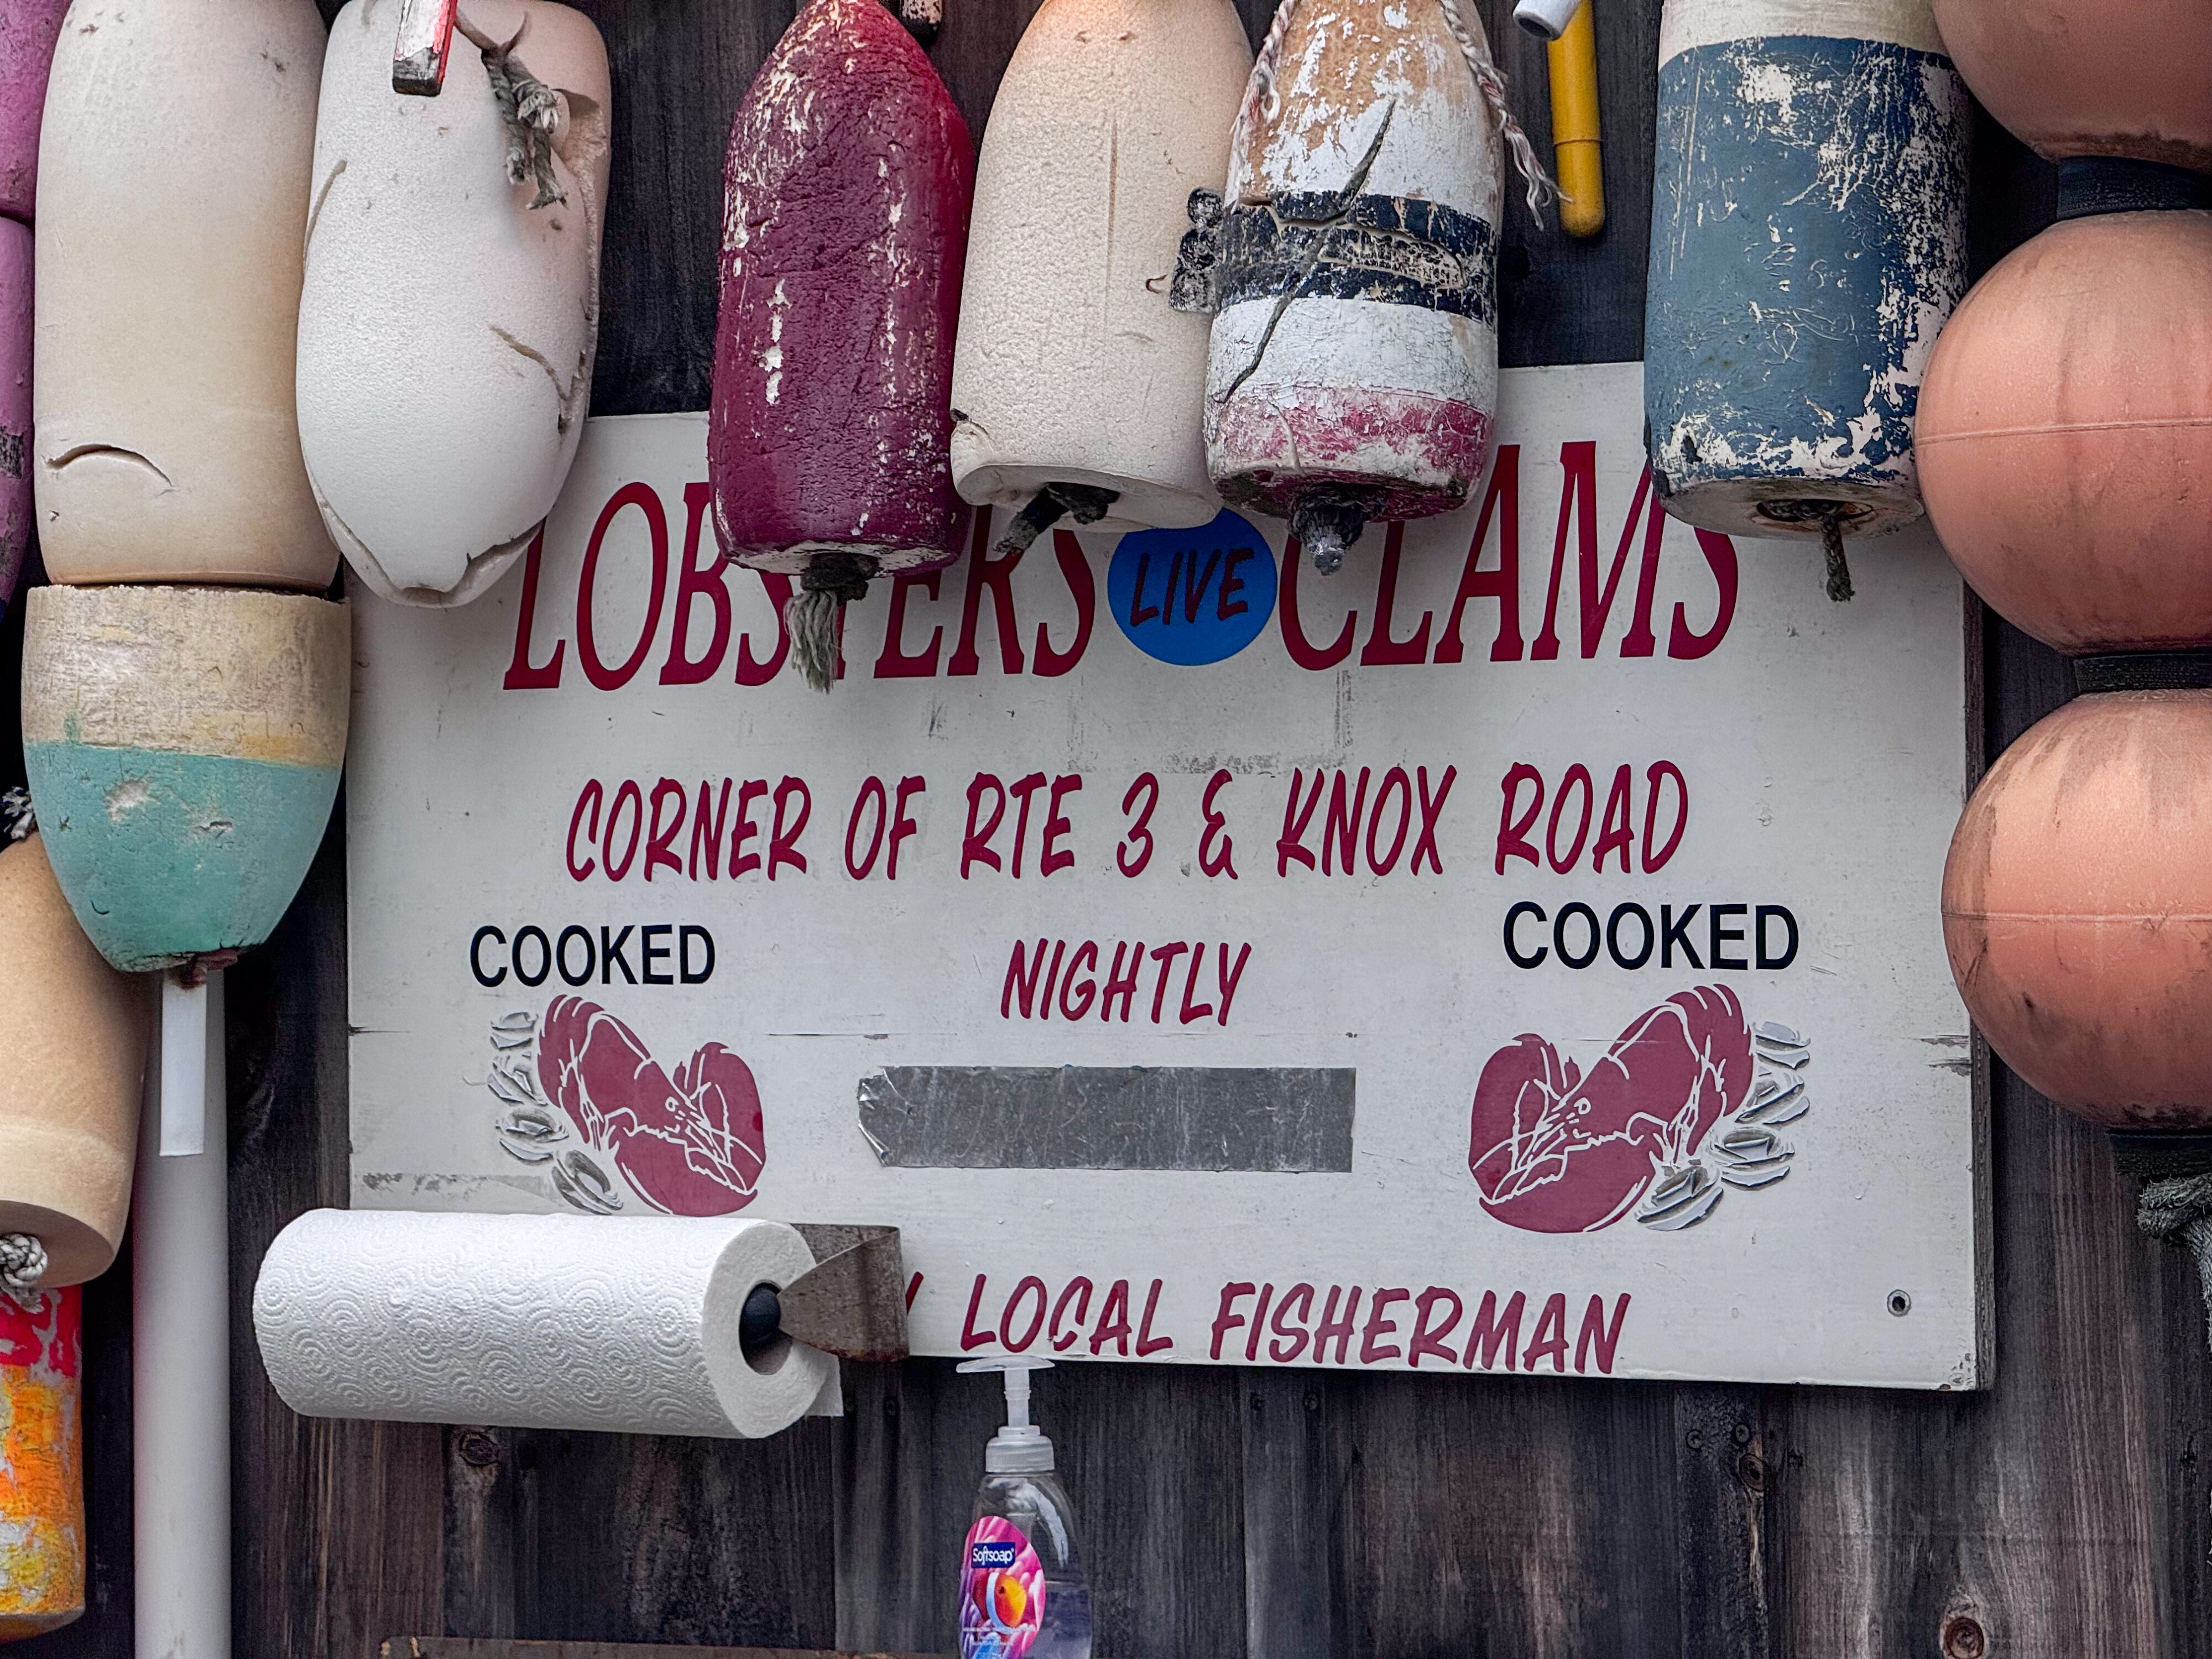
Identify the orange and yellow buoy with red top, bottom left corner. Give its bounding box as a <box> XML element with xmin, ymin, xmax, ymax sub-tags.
<box><xmin>0</xmin><ymin>1290</ymin><xmax>84</xmax><ymax>1641</ymax></box>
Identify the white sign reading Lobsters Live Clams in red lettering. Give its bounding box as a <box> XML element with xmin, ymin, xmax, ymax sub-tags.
<box><xmin>349</xmin><ymin>365</ymin><xmax>1986</xmax><ymax>1387</ymax></box>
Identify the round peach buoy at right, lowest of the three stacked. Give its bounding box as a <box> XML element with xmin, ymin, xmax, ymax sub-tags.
<box><xmin>1942</xmin><ymin>690</ymin><xmax>2212</xmax><ymax>1130</ymax></box>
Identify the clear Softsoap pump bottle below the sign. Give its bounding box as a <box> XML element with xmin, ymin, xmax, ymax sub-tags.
<box><xmin>960</xmin><ymin>1358</ymin><xmax>1091</xmax><ymax>1659</ymax></box>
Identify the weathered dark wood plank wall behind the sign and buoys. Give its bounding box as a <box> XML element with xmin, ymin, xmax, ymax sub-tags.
<box><xmin>0</xmin><ymin>0</ymin><xmax>2212</xmax><ymax>1659</ymax></box>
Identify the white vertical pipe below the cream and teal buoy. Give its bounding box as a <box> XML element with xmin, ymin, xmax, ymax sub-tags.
<box><xmin>131</xmin><ymin>973</ymin><xmax>230</xmax><ymax>1659</ymax></box>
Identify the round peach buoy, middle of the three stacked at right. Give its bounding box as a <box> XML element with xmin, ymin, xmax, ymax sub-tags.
<box><xmin>1918</xmin><ymin>210</ymin><xmax>2212</xmax><ymax>653</ymax></box>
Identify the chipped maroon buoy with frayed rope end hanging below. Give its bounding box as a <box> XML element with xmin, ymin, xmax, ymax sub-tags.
<box><xmin>708</xmin><ymin>0</ymin><xmax>975</xmax><ymax>690</ymax></box>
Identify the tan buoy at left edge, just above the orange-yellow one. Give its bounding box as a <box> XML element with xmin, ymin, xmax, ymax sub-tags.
<box><xmin>0</xmin><ymin>834</ymin><xmax>150</xmax><ymax>1312</ymax></box>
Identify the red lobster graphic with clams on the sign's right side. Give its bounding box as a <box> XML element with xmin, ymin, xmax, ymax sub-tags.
<box><xmin>1467</xmin><ymin>984</ymin><xmax>1761</xmax><ymax>1232</ymax></box>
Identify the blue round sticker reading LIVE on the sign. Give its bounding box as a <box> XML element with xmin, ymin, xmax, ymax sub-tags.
<box><xmin>1106</xmin><ymin>511</ymin><xmax>1274</xmax><ymax>668</ymax></box>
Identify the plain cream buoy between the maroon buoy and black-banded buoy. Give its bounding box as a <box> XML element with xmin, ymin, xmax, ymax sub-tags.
<box><xmin>951</xmin><ymin>0</ymin><xmax>1252</xmax><ymax>560</ymax></box>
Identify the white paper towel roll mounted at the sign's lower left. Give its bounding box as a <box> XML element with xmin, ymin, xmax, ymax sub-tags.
<box><xmin>254</xmin><ymin>1210</ymin><xmax>836</xmax><ymax>1440</ymax></box>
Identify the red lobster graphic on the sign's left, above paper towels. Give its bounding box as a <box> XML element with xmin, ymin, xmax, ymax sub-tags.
<box><xmin>538</xmin><ymin>998</ymin><xmax>768</xmax><ymax>1214</ymax></box>
